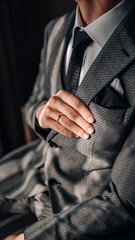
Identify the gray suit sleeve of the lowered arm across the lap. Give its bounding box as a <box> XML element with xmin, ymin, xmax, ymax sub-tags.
<box><xmin>25</xmin><ymin>121</ymin><xmax>135</xmax><ymax>240</ymax></box>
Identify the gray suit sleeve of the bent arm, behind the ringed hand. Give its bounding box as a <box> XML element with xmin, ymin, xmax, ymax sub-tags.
<box><xmin>25</xmin><ymin>23</ymin><xmax>51</xmax><ymax>138</ymax></box>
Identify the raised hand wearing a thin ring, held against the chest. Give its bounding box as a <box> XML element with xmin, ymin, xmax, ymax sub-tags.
<box><xmin>36</xmin><ymin>90</ymin><xmax>94</xmax><ymax>139</ymax></box>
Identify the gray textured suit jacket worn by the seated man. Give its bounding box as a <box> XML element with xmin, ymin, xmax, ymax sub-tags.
<box><xmin>8</xmin><ymin>5</ymin><xmax>135</xmax><ymax>240</ymax></box>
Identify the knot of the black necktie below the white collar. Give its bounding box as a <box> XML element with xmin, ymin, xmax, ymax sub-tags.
<box><xmin>73</xmin><ymin>27</ymin><xmax>93</xmax><ymax>51</ymax></box>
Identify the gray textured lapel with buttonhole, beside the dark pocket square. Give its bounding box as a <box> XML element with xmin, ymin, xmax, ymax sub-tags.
<box><xmin>76</xmin><ymin>4</ymin><xmax>135</xmax><ymax>105</ymax></box>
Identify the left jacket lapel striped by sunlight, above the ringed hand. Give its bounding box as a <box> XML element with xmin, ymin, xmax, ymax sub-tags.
<box><xmin>48</xmin><ymin>10</ymin><xmax>75</xmax><ymax>95</ymax></box>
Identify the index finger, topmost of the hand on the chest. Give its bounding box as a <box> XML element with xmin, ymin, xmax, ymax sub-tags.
<box><xmin>56</xmin><ymin>90</ymin><xmax>94</xmax><ymax>123</ymax></box>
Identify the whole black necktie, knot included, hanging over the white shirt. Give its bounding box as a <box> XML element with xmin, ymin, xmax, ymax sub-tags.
<box><xmin>65</xmin><ymin>27</ymin><xmax>93</xmax><ymax>94</ymax></box>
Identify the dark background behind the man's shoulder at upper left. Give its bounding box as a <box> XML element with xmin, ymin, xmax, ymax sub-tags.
<box><xmin>0</xmin><ymin>0</ymin><xmax>75</xmax><ymax>156</ymax></box>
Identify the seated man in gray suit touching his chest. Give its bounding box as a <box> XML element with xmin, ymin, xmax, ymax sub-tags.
<box><xmin>0</xmin><ymin>0</ymin><xmax>135</xmax><ymax>240</ymax></box>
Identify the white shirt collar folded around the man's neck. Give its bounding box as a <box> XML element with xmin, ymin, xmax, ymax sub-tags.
<box><xmin>74</xmin><ymin>0</ymin><xmax>133</xmax><ymax>48</ymax></box>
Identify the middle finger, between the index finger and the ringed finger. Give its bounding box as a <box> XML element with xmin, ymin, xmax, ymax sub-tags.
<box><xmin>46</xmin><ymin>97</ymin><xmax>94</xmax><ymax>136</ymax></box>
